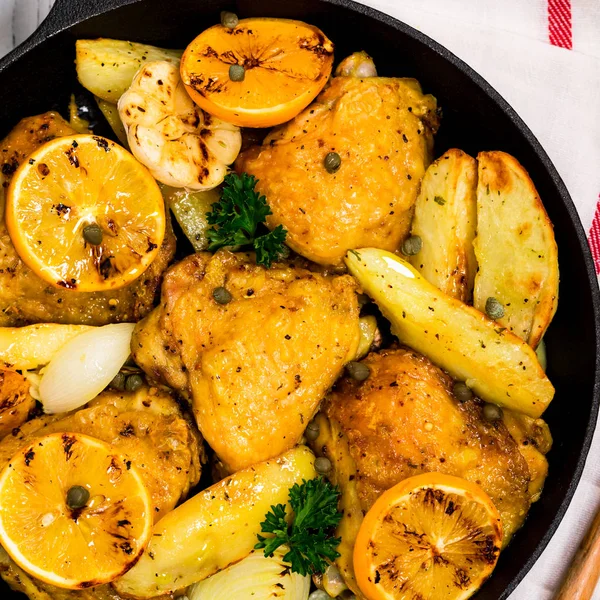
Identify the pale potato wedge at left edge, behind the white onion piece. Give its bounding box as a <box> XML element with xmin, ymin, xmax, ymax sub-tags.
<box><xmin>0</xmin><ymin>323</ymin><xmax>92</xmax><ymax>371</ymax></box>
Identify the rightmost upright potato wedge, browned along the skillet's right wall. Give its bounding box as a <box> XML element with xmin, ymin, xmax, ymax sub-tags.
<box><xmin>473</xmin><ymin>152</ymin><xmax>558</xmax><ymax>348</ymax></box>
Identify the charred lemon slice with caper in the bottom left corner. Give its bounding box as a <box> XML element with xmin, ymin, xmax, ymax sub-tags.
<box><xmin>0</xmin><ymin>433</ymin><xmax>152</xmax><ymax>589</ymax></box>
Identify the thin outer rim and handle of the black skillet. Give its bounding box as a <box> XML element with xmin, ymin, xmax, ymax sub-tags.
<box><xmin>0</xmin><ymin>0</ymin><xmax>600</xmax><ymax>598</ymax></box>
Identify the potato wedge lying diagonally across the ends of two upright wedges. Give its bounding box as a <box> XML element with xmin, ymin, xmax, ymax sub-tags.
<box><xmin>346</xmin><ymin>248</ymin><xmax>554</xmax><ymax>417</ymax></box>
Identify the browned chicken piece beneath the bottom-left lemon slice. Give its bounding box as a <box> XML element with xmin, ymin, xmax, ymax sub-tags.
<box><xmin>0</xmin><ymin>386</ymin><xmax>205</xmax><ymax>600</ymax></box>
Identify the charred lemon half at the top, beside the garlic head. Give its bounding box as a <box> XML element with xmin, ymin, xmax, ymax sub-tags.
<box><xmin>181</xmin><ymin>19</ymin><xmax>333</xmax><ymax>127</ymax></box>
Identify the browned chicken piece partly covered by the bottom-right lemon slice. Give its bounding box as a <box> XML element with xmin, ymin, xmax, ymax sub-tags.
<box><xmin>314</xmin><ymin>348</ymin><xmax>545</xmax><ymax>598</ymax></box>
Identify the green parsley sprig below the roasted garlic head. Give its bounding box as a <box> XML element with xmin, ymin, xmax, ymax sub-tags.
<box><xmin>206</xmin><ymin>173</ymin><xmax>287</xmax><ymax>269</ymax></box>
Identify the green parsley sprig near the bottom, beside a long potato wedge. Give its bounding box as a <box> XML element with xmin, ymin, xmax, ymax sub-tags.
<box><xmin>255</xmin><ymin>478</ymin><xmax>342</xmax><ymax>575</ymax></box>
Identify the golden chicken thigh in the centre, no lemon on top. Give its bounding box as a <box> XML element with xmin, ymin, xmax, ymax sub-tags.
<box><xmin>131</xmin><ymin>251</ymin><xmax>359</xmax><ymax>471</ymax></box>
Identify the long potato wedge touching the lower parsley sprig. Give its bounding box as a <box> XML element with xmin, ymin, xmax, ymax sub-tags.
<box><xmin>113</xmin><ymin>446</ymin><xmax>316</xmax><ymax>598</ymax></box>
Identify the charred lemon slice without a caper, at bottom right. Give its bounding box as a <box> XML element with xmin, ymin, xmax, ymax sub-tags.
<box><xmin>354</xmin><ymin>473</ymin><xmax>502</xmax><ymax>600</ymax></box>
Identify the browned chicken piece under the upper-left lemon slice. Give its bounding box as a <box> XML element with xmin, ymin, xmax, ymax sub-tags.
<box><xmin>0</xmin><ymin>112</ymin><xmax>175</xmax><ymax>327</ymax></box>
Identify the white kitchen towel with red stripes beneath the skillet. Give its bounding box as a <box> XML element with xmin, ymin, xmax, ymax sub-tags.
<box><xmin>0</xmin><ymin>0</ymin><xmax>600</xmax><ymax>600</ymax></box>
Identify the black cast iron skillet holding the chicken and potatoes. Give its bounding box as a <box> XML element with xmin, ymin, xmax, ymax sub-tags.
<box><xmin>0</xmin><ymin>0</ymin><xmax>600</xmax><ymax>600</ymax></box>
